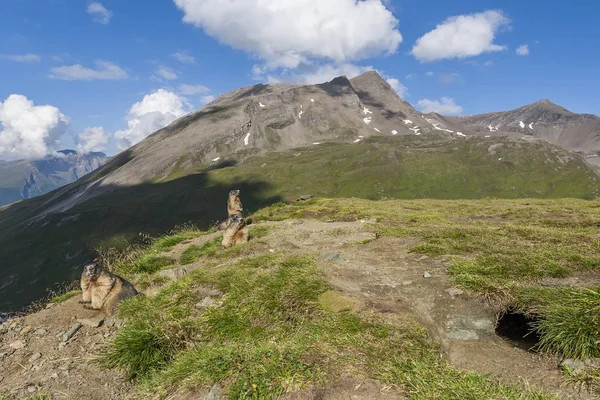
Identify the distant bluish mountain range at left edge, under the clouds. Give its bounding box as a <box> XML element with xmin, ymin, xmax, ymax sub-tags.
<box><xmin>0</xmin><ymin>150</ymin><xmax>108</xmax><ymax>206</ymax></box>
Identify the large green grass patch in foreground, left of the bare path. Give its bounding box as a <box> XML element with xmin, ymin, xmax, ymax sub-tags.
<box><xmin>102</xmin><ymin>254</ymin><xmax>549</xmax><ymax>400</ymax></box>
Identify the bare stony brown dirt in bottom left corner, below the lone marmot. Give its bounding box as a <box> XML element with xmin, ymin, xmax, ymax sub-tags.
<box><xmin>0</xmin><ymin>296</ymin><xmax>132</xmax><ymax>400</ymax></box>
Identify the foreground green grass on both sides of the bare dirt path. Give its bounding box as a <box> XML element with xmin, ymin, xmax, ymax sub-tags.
<box><xmin>92</xmin><ymin>199</ymin><xmax>600</xmax><ymax>400</ymax></box>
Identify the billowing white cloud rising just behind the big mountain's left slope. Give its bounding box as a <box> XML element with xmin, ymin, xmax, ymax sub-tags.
<box><xmin>115</xmin><ymin>89</ymin><xmax>190</xmax><ymax>150</ymax></box>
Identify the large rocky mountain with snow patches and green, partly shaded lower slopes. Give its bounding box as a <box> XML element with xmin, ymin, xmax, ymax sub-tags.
<box><xmin>0</xmin><ymin>72</ymin><xmax>600</xmax><ymax>312</ymax></box>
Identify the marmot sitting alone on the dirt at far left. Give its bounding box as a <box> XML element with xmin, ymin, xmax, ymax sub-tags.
<box><xmin>81</xmin><ymin>263</ymin><xmax>138</xmax><ymax>317</ymax></box>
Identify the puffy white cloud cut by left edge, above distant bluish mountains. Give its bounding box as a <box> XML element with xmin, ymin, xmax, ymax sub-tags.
<box><xmin>0</xmin><ymin>94</ymin><xmax>69</xmax><ymax>160</ymax></box>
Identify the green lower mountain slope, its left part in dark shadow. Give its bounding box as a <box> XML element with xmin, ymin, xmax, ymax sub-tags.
<box><xmin>0</xmin><ymin>136</ymin><xmax>600</xmax><ymax>311</ymax></box>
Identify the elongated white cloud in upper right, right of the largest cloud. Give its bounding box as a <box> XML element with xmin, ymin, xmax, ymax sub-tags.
<box><xmin>411</xmin><ymin>10</ymin><xmax>510</xmax><ymax>62</ymax></box>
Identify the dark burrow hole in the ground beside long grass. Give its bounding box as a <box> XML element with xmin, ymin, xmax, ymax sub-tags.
<box><xmin>496</xmin><ymin>309</ymin><xmax>540</xmax><ymax>351</ymax></box>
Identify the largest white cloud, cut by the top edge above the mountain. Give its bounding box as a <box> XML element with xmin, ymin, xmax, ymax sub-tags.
<box><xmin>174</xmin><ymin>0</ymin><xmax>402</xmax><ymax>68</ymax></box>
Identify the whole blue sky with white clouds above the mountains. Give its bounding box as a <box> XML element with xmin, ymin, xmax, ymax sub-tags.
<box><xmin>0</xmin><ymin>0</ymin><xmax>600</xmax><ymax>159</ymax></box>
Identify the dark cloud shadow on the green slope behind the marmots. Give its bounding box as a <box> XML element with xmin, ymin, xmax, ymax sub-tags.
<box><xmin>0</xmin><ymin>172</ymin><xmax>282</xmax><ymax>312</ymax></box>
